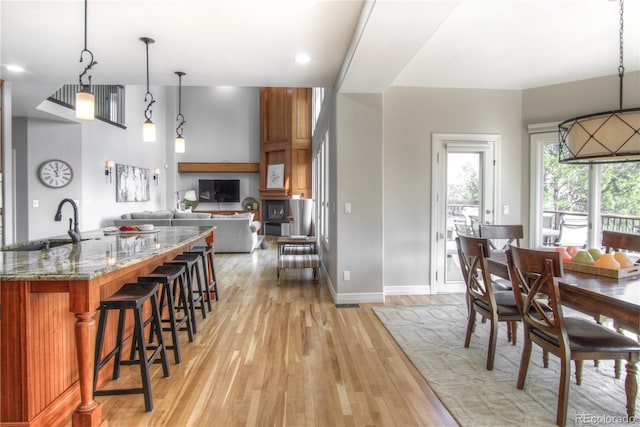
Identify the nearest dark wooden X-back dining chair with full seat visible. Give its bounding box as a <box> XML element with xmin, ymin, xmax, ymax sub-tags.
<box><xmin>508</xmin><ymin>246</ymin><xmax>640</xmax><ymax>426</ymax></box>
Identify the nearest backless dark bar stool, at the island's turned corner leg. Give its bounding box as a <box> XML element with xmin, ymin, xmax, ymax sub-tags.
<box><xmin>93</xmin><ymin>283</ymin><xmax>169</xmax><ymax>412</ymax></box>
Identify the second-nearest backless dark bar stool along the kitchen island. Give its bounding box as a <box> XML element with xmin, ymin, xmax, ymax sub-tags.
<box><xmin>138</xmin><ymin>264</ymin><xmax>193</xmax><ymax>365</ymax></box>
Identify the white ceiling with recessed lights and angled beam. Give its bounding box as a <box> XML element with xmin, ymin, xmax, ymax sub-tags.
<box><xmin>0</xmin><ymin>0</ymin><xmax>640</xmax><ymax>115</ymax></box>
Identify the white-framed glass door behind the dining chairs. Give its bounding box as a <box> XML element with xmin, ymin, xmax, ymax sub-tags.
<box><xmin>431</xmin><ymin>134</ymin><xmax>500</xmax><ymax>293</ymax></box>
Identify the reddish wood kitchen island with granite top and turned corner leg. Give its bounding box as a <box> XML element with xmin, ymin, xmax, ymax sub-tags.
<box><xmin>0</xmin><ymin>227</ymin><xmax>215</xmax><ymax>426</ymax></box>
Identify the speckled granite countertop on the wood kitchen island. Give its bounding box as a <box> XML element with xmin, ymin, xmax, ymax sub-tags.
<box><xmin>0</xmin><ymin>226</ymin><xmax>215</xmax><ymax>281</ymax></box>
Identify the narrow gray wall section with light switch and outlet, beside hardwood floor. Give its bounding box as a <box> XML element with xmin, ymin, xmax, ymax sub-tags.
<box><xmin>335</xmin><ymin>94</ymin><xmax>384</xmax><ymax>303</ymax></box>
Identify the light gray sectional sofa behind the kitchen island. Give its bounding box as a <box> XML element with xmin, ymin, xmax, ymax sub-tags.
<box><xmin>113</xmin><ymin>210</ymin><xmax>262</xmax><ymax>253</ymax></box>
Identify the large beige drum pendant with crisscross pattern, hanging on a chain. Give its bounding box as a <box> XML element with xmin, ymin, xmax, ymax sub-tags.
<box><xmin>558</xmin><ymin>0</ymin><xmax>640</xmax><ymax>163</ymax></box>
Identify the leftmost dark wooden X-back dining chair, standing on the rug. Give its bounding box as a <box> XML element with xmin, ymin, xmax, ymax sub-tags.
<box><xmin>456</xmin><ymin>236</ymin><xmax>520</xmax><ymax>370</ymax></box>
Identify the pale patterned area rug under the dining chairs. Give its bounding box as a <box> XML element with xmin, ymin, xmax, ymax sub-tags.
<box><xmin>373</xmin><ymin>305</ymin><xmax>628</xmax><ymax>426</ymax></box>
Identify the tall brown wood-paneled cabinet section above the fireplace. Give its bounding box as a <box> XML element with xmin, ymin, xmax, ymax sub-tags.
<box><xmin>260</xmin><ymin>87</ymin><xmax>311</xmax><ymax>200</ymax></box>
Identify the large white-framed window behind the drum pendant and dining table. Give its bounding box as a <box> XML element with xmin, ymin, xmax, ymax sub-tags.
<box><xmin>531</xmin><ymin>131</ymin><xmax>640</xmax><ymax>247</ymax></box>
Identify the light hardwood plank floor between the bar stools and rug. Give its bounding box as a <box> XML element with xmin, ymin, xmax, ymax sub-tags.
<box><xmin>87</xmin><ymin>238</ymin><xmax>462</xmax><ymax>427</ymax></box>
